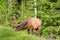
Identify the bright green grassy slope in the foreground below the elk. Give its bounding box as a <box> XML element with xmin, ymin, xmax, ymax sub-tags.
<box><xmin>0</xmin><ymin>27</ymin><xmax>60</xmax><ymax>40</ymax></box>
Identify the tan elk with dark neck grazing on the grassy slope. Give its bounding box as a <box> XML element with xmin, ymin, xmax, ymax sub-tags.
<box><xmin>9</xmin><ymin>18</ymin><xmax>42</xmax><ymax>36</ymax></box>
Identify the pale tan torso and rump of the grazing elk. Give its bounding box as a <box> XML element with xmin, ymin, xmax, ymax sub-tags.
<box><xmin>26</xmin><ymin>18</ymin><xmax>42</xmax><ymax>29</ymax></box>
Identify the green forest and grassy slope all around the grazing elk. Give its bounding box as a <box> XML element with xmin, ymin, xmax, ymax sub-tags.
<box><xmin>0</xmin><ymin>0</ymin><xmax>60</xmax><ymax>40</ymax></box>
